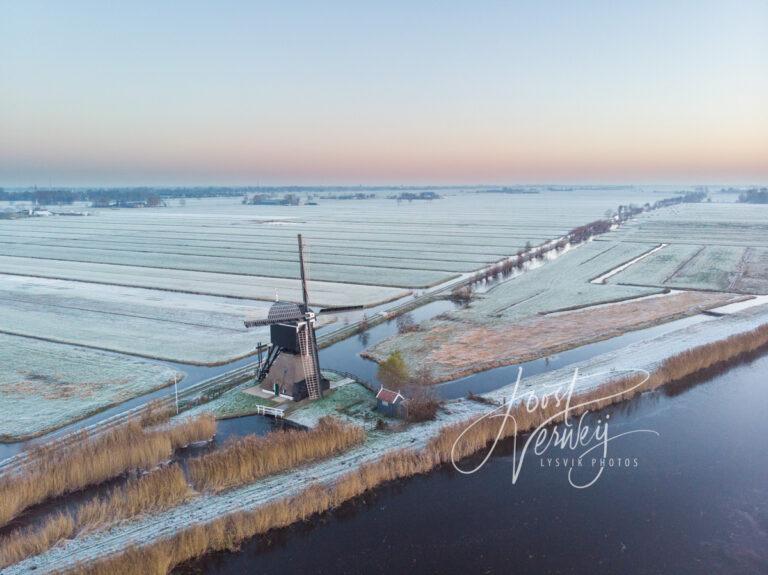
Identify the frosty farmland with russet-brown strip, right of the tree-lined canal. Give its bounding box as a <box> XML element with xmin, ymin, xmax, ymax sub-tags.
<box><xmin>368</xmin><ymin>203</ymin><xmax>768</xmax><ymax>380</ymax></box>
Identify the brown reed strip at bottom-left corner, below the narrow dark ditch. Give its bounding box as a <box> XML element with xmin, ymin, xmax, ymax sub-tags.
<box><xmin>0</xmin><ymin>465</ymin><xmax>190</xmax><ymax>569</ymax></box>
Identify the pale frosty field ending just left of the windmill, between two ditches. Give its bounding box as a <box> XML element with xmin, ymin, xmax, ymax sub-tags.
<box><xmin>0</xmin><ymin>276</ymin><xmax>269</xmax><ymax>364</ymax></box>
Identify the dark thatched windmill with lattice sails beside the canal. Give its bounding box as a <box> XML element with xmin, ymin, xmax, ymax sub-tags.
<box><xmin>245</xmin><ymin>234</ymin><xmax>331</xmax><ymax>401</ymax></box>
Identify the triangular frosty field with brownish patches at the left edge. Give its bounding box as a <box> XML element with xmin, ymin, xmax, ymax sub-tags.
<box><xmin>0</xmin><ymin>334</ymin><xmax>183</xmax><ymax>441</ymax></box>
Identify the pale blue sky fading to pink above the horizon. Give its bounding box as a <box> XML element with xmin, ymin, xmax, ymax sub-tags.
<box><xmin>0</xmin><ymin>0</ymin><xmax>768</xmax><ymax>187</ymax></box>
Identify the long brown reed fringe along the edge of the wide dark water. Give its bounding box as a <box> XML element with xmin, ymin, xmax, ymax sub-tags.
<box><xmin>58</xmin><ymin>325</ymin><xmax>768</xmax><ymax>575</ymax></box>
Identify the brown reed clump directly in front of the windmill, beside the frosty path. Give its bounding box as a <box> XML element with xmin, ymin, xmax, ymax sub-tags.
<box><xmin>187</xmin><ymin>417</ymin><xmax>365</xmax><ymax>491</ymax></box>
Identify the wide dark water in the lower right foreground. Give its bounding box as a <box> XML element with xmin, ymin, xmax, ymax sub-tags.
<box><xmin>177</xmin><ymin>346</ymin><xmax>768</xmax><ymax>575</ymax></box>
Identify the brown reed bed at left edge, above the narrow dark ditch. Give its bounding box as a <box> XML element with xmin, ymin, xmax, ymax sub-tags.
<box><xmin>0</xmin><ymin>414</ymin><xmax>216</xmax><ymax>526</ymax></box>
